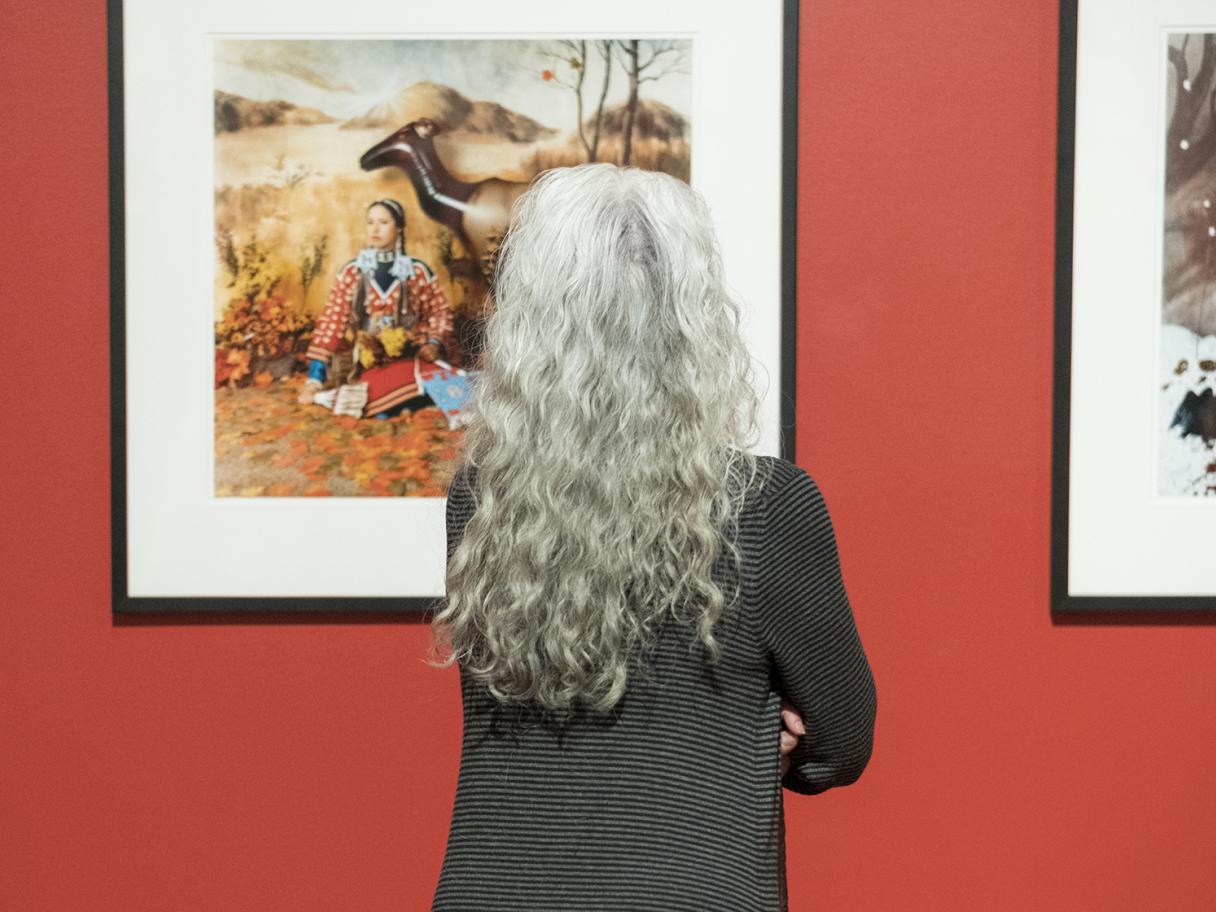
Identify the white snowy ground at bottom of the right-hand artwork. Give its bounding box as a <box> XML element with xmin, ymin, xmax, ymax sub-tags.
<box><xmin>1158</xmin><ymin>323</ymin><xmax>1216</xmax><ymax>497</ymax></box>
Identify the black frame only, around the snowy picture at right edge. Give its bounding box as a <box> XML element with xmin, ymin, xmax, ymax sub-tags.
<box><xmin>1051</xmin><ymin>0</ymin><xmax>1216</xmax><ymax>620</ymax></box>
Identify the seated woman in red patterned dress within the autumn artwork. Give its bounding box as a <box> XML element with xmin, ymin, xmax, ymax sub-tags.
<box><xmin>300</xmin><ymin>199</ymin><xmax>455</xmax><ymax>417</ymax></box>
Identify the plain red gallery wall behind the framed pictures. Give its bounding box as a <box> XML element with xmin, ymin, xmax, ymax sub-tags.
<box><xmin>0</xmin><ymin>0</ymin><xmax>1216</xmax><ymax>912</ymax></box>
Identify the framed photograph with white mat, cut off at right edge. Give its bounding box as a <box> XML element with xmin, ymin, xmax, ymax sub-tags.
<box><xmin>1052</xmin><ymin>0</ymin><xmax>1216</xmax><ymax>613</ymax></box>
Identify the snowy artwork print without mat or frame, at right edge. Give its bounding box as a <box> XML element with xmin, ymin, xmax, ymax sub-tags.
<box><xmin>1158</xmin><ymin>32</ymin><xmax>1216</xmax><ymax>497</ymax></box>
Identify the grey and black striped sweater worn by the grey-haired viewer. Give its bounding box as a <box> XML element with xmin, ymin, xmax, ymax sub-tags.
<box><xmin>432</xmin><ymin>456</ymin><xmax>877</xmax><ymax>912</ymax></box>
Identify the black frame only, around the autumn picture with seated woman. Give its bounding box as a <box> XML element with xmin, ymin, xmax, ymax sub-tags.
<box><xmin>107</xmin><ymin>0</ymin><xmax>799</xmax><ymax>621</ymax></box>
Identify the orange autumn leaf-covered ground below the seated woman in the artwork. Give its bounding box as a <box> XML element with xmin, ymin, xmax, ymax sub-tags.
<box><xmin>215</xmin><ymin>376</ymin><xmax>463</xmax><ymax>497</ymax></box>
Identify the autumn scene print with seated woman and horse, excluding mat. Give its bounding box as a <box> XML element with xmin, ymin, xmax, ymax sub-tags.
<box><xmin>212</xmin><ymin>36</ymin><xmax>690</xmax><ymax>499</ymax></box>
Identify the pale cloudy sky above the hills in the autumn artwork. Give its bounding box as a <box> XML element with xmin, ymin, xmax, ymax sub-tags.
<box><xmin>214</xmin><ymin>39</ymin><xmax>693</xmax><ymax>130</ymax></box>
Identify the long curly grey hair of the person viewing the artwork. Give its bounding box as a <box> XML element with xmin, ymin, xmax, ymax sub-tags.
<box><xmin>430</xmin><ymin>163</ymin><xmax>762</xmax><ymax>711</ymax></box>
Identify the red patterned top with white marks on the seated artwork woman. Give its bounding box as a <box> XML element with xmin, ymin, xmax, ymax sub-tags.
<box><xmin>308</xmin><ymin>259</ymin><xmax>452</xmax><ymax>365</ymax></box>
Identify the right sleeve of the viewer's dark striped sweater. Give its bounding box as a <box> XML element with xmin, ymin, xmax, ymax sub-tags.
<box><xmin>756</xmin><ymin>468</ymin><xmax>878</xmax><ymax>795</ymax></box>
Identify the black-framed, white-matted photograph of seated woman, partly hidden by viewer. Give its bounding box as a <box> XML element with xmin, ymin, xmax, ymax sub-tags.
<box><xmin>108</xmin><ymin>0</ymin><xmax>798</xmax><ymax>613</ymax></box>
